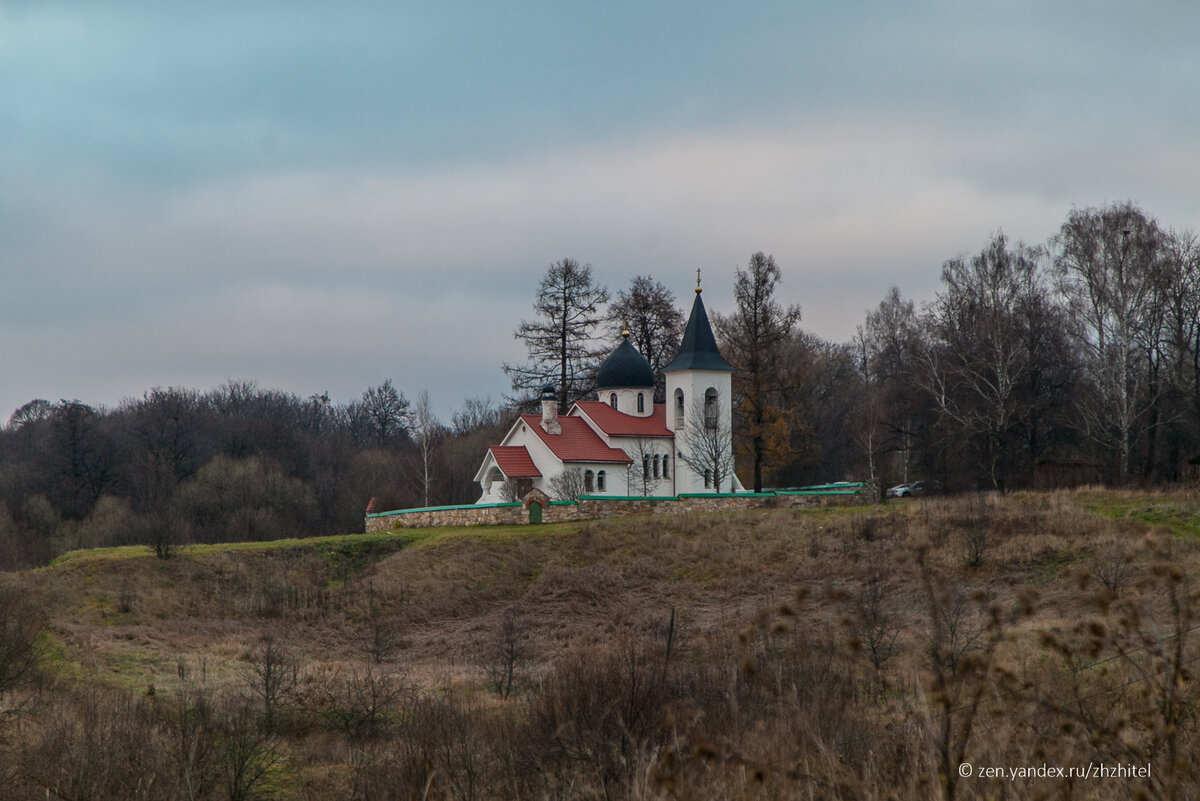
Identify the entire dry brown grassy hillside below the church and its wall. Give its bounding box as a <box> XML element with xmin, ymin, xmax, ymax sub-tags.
<box><xmin>0</xmin><ymin>490</ymin><xmax>1200</xmax><ymax>801</ymax></box>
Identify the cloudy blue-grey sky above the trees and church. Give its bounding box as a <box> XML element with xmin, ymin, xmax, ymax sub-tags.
<box><xmin>0</xmin><ymin>0</ymin><xmax>1200</xmax><ymax>423</ymax></box>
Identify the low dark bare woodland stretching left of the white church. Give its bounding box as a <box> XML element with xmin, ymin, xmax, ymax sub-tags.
<box><xmin>0</xmin><ymin>379</ymin><xmax>511</xmax><ymax>567</ymax></box>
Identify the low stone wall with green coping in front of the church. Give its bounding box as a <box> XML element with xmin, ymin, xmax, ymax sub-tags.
<box><xmin>366</xmin><ymin>490</ymin><xmax>870</xmax><ymax>532</ymax></box>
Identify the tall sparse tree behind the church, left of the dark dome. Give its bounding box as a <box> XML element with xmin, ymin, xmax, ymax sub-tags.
<box><xmin>504</xmin><ymin>259</ymin><xmax>608</xmax><ymax>412</ymax></box>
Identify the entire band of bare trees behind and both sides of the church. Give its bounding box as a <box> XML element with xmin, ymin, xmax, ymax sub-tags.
<box><xmin>0</xmin><ymin>197</ymin><xmax>1200</xmax><ymax>566</ymax></box>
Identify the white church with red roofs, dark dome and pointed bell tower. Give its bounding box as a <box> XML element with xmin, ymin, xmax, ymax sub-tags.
<box><xmin>475</xmin><ymin>276</ymin><xmax>744</xmax><ymax>504</ymax></box>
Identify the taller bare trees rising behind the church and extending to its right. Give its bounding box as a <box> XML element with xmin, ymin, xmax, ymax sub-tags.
<box><xmin>505</xmin><ymin>203</ymin><xmax>1200</xmax><ymax>490</ymax></box>
